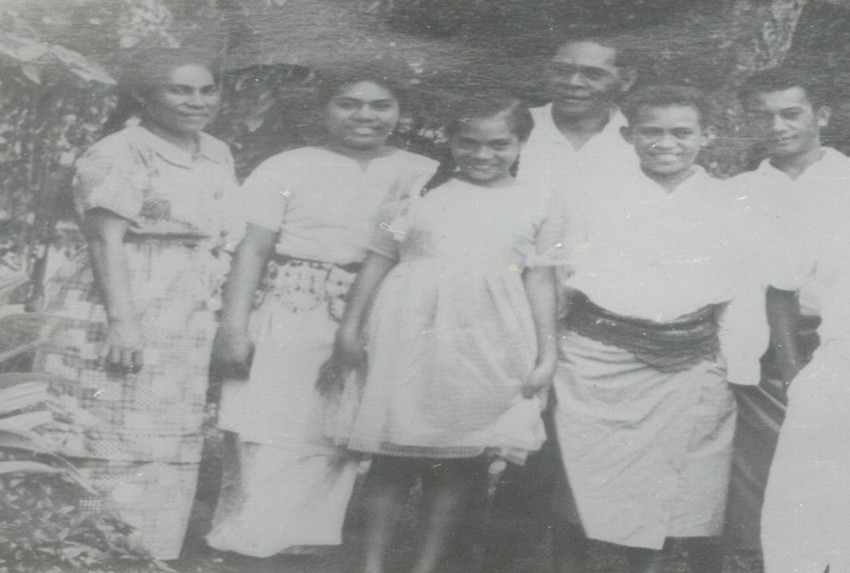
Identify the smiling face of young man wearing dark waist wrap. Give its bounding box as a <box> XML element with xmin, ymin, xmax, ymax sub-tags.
<box><xmin>623</xmin><ymin>105</ymin><xmax>710</xmax><ymax>179</ymax></box>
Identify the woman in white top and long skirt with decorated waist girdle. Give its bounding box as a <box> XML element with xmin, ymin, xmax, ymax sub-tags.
<box><xmin>202</xmin><ymin>62</ymin><xmax>436</xmax><ymax>558</ymax></box>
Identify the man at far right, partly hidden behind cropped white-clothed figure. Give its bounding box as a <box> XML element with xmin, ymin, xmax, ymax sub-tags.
<box><xmin>726</xmin><ymin>68</ymin><xmax>850</xmax><ymax>549</ymax></box>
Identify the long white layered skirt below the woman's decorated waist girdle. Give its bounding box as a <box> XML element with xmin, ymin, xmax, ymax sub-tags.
<box><xmin>207</xmin><ymin>297</ymin><xmax>357</xmax><ymax>557</ymax></box>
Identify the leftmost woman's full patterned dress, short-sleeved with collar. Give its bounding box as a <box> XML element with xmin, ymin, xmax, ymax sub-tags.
<box><xmin>34</xmin><ymin>126</ymin><xmax>236</xmax><ymax>559</ymax></box>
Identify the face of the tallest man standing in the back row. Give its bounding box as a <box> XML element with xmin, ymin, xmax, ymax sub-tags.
<box><xmin>546</xmin><ymin>41</ymin><xmax>634</xmax><ymax>119</ymax></box>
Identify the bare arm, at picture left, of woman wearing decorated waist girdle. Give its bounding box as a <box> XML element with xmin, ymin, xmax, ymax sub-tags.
<box><xmin>213</xmin><ymin>223</ymin><xmax>277</xmax><ymax>378</ymax></box>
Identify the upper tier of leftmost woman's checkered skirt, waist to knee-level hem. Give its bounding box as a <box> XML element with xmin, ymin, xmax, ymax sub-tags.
<box><xmin>34</xmin><ymin>241</ymin><xmax>215</xmax><ymax>463</ymax></box>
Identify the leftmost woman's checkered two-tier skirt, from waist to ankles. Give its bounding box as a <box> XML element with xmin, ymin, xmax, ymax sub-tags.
<box><xmin>34</xmin><ymin>240</ymin><xmax>218</xmax><ymax>559</ymax></box>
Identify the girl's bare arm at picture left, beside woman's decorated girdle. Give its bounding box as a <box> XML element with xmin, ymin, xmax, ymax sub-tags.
<box><xmin>316</xmin><ymin>252</ymin><xmax>396</xmax><ymax>393</ymax></box>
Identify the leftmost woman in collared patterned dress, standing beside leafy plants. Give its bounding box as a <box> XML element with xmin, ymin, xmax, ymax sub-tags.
<box><xmin>35</xmin><ymin>48</ymin><xmax>236</xmax><ymax>559</ymax></box>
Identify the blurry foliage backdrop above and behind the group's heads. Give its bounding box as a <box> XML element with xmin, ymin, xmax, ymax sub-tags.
<box><xmin>0</xmin><ymin>0</ymin><xmax>848</xmax><ymax>264</ymax></box>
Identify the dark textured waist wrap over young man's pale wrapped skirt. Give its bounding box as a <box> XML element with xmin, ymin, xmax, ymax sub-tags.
<box><xmin>564</xmin><ymin>293</ymin><xmax>722</xmax><ymax>372</ymax></box>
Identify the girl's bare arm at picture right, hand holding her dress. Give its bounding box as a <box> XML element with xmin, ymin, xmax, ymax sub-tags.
<box><xmin>523</xmin><ymin>267</ymin><xmax>558</xmax><ymax>398</ymax></box>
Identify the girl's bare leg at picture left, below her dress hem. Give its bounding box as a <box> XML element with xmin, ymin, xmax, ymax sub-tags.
<box><xmin>363</xmin><ymin>456</ymin><xmax>416</xmax><ymax>573</ymax></box>
